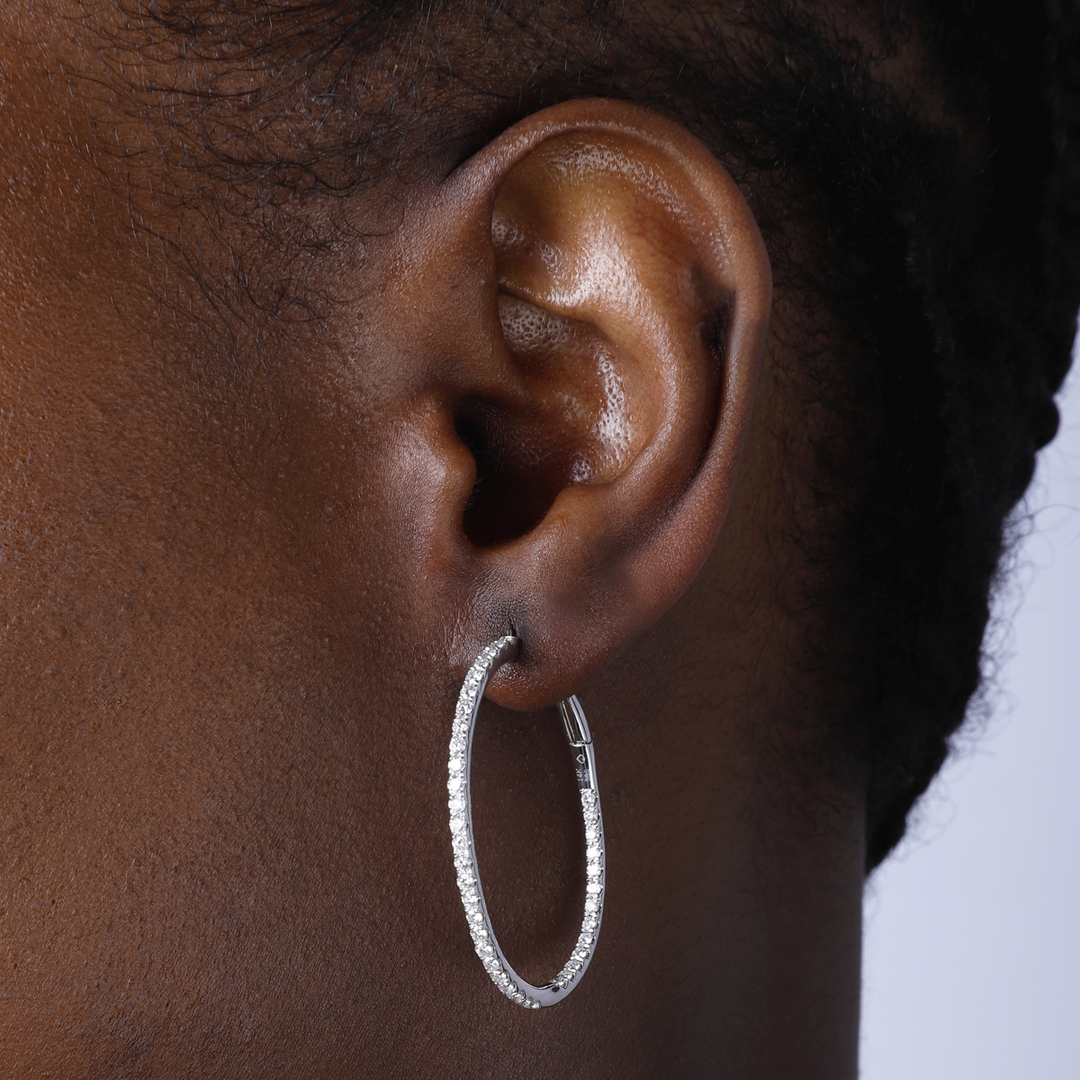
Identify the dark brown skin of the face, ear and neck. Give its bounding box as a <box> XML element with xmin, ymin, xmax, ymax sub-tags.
<box><xmin>0</xmin><ymin>4</ymin><xmax>864</xmax><ymax>1080</ymax></box>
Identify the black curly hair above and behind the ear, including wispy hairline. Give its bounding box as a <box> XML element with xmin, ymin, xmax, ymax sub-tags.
<box><xmin>122</xmin><ymin>0</ymin><xmax>1080</xmax><ymax>868</ymax></box>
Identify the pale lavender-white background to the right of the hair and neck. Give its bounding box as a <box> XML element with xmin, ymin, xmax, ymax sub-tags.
<box><xmin>862</xmin><ymin>349</ymin><xmax>1080</xmax><ymax>1080</ymax></box>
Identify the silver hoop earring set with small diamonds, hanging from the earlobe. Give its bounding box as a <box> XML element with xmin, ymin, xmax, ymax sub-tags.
<box><xmin>446</xmin><ymin>635</ymin><xmax>604</xmax><ymax>1009</ymax></box>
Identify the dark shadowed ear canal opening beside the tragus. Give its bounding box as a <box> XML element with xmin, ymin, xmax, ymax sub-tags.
<box><xmin>454</xmin><ymin>399</ymin><xmax>571</xmax><ymax>548</ymax></box>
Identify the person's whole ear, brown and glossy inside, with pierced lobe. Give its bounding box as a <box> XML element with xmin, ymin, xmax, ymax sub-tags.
<box><xmin>375</xmin><ymin>100</ymin><xmax>771</xmax><ymax>708</ymax></box>
